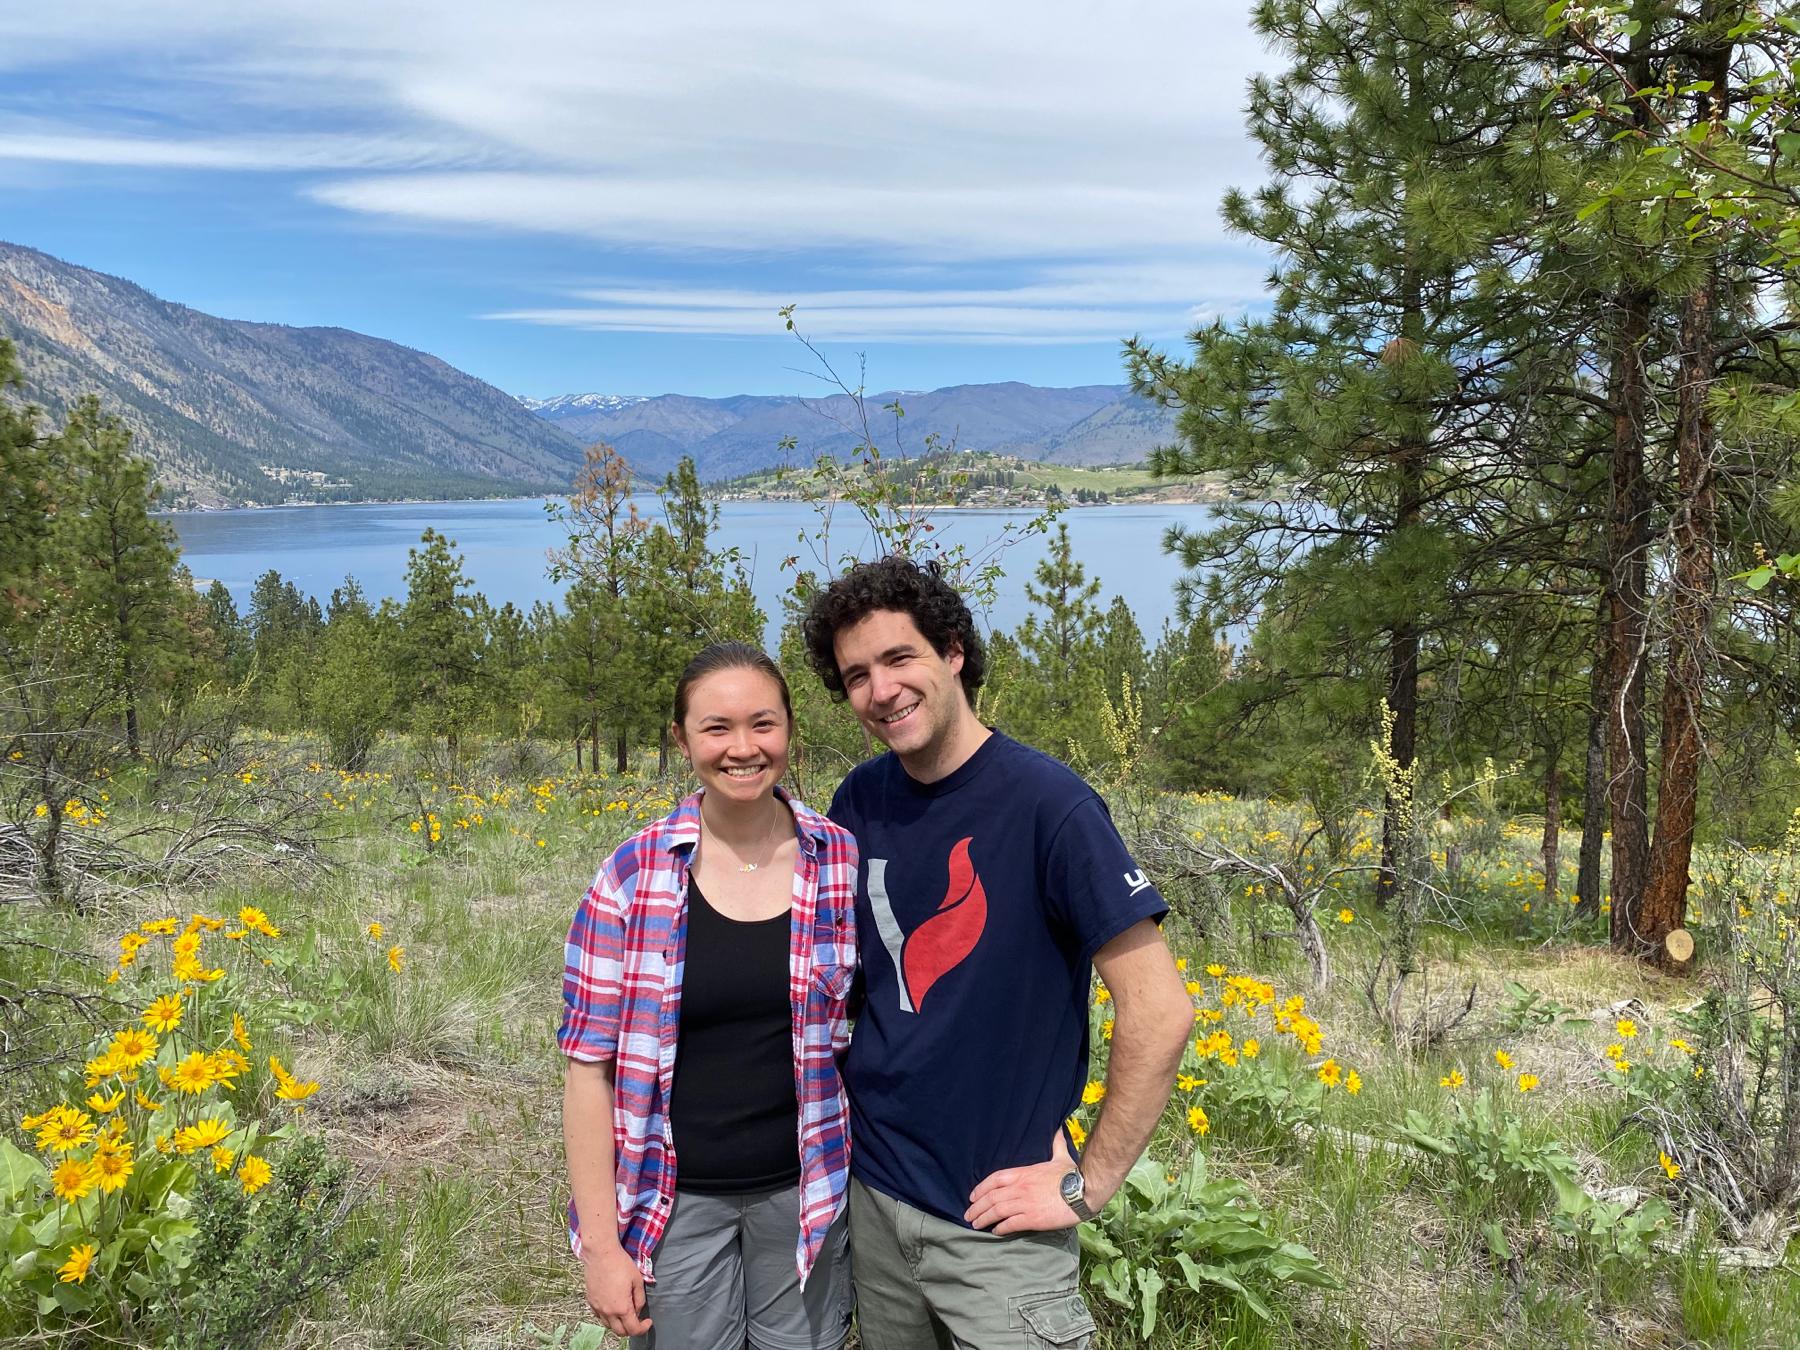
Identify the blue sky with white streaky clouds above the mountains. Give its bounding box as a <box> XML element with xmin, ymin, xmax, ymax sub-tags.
<box><xmin>0</xmin><ymin>0</ymin><xmax>1273</xmax><ymax>398</ymax></box>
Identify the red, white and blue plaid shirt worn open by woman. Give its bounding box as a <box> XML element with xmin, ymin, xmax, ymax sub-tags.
<box><xmin>556</xmin><ymin>788</ymin><xmax>857</xmax><ymax>1282</ymax></box>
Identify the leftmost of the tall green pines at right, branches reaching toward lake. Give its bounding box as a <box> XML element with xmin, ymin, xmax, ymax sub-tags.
<box><xmin>1127</xmin><ymin>0</ymin><xmax>1543</xmax><ymax>910</ymax></box>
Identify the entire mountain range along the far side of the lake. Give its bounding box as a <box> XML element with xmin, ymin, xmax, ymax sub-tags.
<box><xmin>0</xmin><ymin>241</ymin><xmax>1174</xmax><ymax>508</ymax></box>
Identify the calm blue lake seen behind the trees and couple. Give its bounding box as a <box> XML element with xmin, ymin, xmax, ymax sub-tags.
<box><xmin>164</xmin><ymin>497</ymin><xmax>1211</xmax><ymax>650</ymax></box>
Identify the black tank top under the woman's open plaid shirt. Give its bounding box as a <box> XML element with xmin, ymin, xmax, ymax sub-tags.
<box><xmin>670</xmin><ymin>877</ymin><xmax>799</xmax><ymax>1195</ymax></box>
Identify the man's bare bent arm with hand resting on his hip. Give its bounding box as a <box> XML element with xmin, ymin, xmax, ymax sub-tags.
<box><xmin>963</xmin><ymin>920</ymin><xmax>1193</xmax><ymax>1233</ymax></box>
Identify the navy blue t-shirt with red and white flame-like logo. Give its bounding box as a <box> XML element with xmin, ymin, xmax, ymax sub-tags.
<box><xmin>830</xmin><ymin>733</ymin><xmax>1168</xmax><ymax>1224</ymax></box>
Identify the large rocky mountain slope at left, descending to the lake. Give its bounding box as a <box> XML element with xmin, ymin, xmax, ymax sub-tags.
<box><xmin>0</xmin><ymin>243</ymin><xmax>581</xmax><ymax>506</ymax></box>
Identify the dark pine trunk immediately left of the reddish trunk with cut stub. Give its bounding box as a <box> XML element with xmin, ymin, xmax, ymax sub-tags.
<box><xmin>1606</xmin><ymin>290</ymin><xmax>1651</xmax><ymax>950</ymax></box>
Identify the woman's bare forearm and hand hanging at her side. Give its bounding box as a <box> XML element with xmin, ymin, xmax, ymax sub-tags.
<box><xmin>563</xmin><ymin>1058</ymin><xmax>650</xmax><ymax>1336</ymax></box>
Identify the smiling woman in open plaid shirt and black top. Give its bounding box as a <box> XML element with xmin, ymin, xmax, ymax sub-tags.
<box><xmin>556</xmin><ymin>643</ymin><xmax>857</xmax><ymax>1350</ymax></box>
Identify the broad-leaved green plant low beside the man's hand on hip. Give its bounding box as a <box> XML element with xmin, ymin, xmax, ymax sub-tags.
<box><xmin>1080</xmin><ymin>1150</ymin><xmax>1337</xmax><ymax>1337</ymax></box>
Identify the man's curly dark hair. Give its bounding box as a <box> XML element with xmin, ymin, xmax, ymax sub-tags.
<box><xmin>801</xmin><ymin>554</ymin><xmax>988</xmax><ymax>704</ymax></box>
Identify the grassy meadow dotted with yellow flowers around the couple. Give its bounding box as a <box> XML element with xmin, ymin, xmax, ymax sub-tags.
<box><xmin>0</xmin><ymin>742</ymin><xmax>1800</xmax><ymax>1350</ymax></box>
